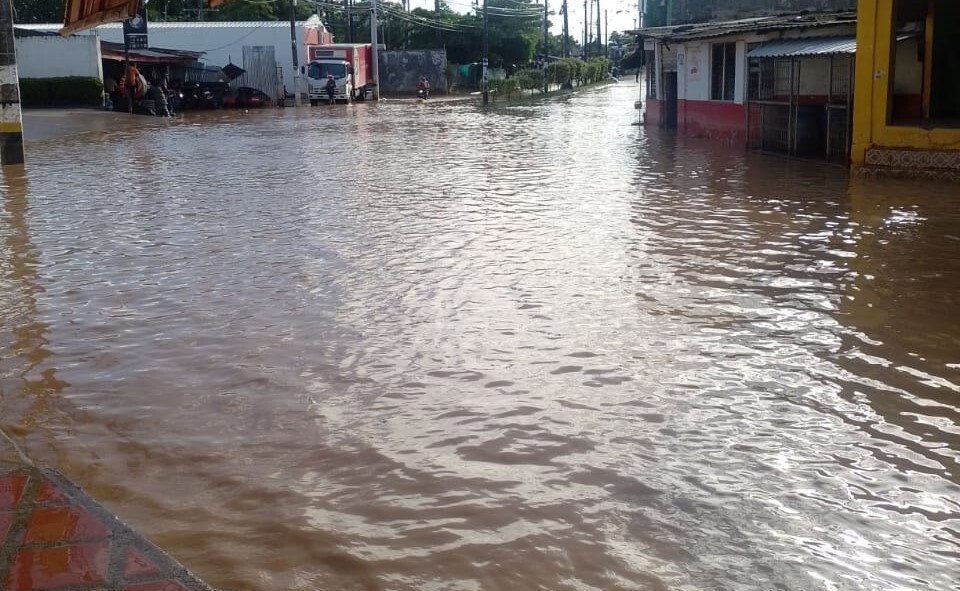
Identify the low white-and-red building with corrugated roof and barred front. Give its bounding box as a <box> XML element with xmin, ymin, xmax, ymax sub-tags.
<box><xmin>636</xmin><ymin>11</ymin><xmax>856</xmax><ymax>163</ymax></box>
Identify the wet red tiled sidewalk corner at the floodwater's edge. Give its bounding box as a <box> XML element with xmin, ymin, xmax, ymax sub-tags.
<box><xmin>0</xmin><ymin>464</ymin><xmax>212</xmax><ymax>591</ymax></box>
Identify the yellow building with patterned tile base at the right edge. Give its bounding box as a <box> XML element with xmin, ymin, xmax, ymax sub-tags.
<box><xmin>851</xmin><ymin>0</ymin><xmax>960</xmax><ymax>180</ymax></box>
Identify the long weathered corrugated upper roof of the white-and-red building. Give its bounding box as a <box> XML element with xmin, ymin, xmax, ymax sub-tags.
<box><xmin>633</xmin><ymin>10</ymin><xmax>857</xmax><ymax>41</ymax></box>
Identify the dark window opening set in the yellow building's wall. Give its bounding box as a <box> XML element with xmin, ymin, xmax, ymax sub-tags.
<box><xmin>889</xmin><ymin>0</ymin><xmax>960</xmax><ymax>126</ymax></box>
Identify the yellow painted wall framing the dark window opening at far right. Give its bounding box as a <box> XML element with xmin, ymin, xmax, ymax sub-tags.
<box><xmin>850</xmin><ymin>0</ymin><xmax>960</xmax><ymax>166</ymax></box>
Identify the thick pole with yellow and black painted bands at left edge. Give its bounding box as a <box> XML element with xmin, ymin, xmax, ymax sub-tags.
<box><xmin>0</xmin><ymin>0</ymin><xmax>24</xmax><ymax>166</ymax></box>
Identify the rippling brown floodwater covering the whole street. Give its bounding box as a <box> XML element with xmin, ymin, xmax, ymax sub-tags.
<box><xmin>0</xmin><ymin>84</ymin><xmax>960</xmax><ymax>591</ymax></box>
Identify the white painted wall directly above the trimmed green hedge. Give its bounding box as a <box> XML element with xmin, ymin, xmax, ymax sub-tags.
<box><xmin>15</xmin><ymin>34</ymin><xmax>103</xmax><ymax>80</ymax></box>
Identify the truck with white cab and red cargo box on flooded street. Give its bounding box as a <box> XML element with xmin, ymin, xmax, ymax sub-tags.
<box><xmin>307</xmin><ymin>43</ymin><xmax>373</xmax><ymax>105</ymax></box>
